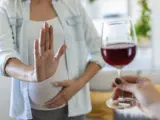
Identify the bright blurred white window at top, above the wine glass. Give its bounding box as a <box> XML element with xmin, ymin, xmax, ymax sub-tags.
<box><xmin>84</xmin><ymin>0</ymin><xmax>129</xmax><ymax>19</ymax></box>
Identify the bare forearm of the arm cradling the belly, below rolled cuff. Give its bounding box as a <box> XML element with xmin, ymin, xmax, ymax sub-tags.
<box><xmin>80</xmin><ymin>62</ymin><xmax>101</xmax><ymax>85</ymax></box>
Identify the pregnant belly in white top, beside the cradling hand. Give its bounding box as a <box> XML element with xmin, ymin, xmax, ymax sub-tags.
<box><xmin>29</xmin><ymin>80</ymin><xmax>62</xmax><ymax>105</ymax></box>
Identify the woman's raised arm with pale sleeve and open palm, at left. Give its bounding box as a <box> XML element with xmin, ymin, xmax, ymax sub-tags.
<box><xmin>0</xmin><ymin>8</ymin><xmax>66</xmax><ymax>82</ymax></box>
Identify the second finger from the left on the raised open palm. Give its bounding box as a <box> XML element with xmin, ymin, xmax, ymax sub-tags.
<box><xmin>39</xmin><ymin>28</ymin><xmax>45</xmax><ymax>55</ymax></box>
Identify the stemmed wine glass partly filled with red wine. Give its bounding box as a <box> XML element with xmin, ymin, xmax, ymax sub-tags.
<box><xmin>101</xmin><ymin>19</ymin><xmax>137</xmax><ymax>109</ymax></box>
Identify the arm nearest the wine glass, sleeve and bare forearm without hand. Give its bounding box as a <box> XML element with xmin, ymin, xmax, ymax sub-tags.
<box><xmin>78</xmin><ymin>0</ymin><xmax>105</xmax><ymax>84</ymax></box>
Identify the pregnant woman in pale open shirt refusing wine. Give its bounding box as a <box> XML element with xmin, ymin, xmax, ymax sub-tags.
<box><xmin>0</xmin><ymin>0</ymin><xmax>104</xmax><ymax>120</ymax></box>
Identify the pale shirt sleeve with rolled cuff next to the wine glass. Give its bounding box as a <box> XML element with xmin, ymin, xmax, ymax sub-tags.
<box><xmin>77</xmin><ymin>0</ymin><xmax>105</xmax><ymax>67</ymax></box>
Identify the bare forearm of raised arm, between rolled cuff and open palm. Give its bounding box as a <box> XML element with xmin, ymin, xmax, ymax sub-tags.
<box><xmin>5</xmin><ymin>58</ymin><xmax>33</xmax><ymax>82</ymax></box>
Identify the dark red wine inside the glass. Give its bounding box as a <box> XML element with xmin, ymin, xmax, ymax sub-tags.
<box><xmin>101</xmin><ymin>43</ymin><xmax>136</xmax><ymax>67</ymax></box>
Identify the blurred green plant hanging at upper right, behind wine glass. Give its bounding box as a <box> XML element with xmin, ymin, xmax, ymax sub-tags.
<box><xmin>135</xmin><ymin>0</ymin><xmax>151</xmax><ymax>40</ymax></box>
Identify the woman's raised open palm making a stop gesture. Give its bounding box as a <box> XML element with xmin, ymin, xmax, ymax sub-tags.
<box><xmin>33</xmin><ymin>23</ymin><xmax>66</xmax><ymax>82</ymax></box>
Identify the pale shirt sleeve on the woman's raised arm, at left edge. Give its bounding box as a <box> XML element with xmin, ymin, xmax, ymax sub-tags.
<box><xmin>0</xmin><ymin>8</ymin><xmax>19</xmax><ymax>76</ymax></box>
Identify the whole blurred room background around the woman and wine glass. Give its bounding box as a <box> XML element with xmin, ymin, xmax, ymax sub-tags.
<box><xmin>0</xmin><ymin>0</ymin><xmax>160</xmax><ymax>120</ymax></box>
